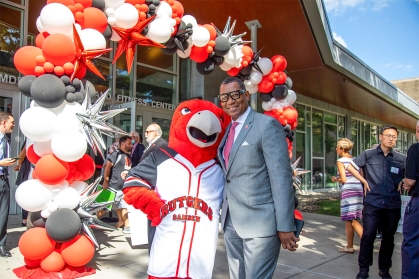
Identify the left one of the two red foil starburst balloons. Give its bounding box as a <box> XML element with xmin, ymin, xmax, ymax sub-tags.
<box><xmin>70</xmin><ymin>25</ymin><xmax>112</xmax><ymax>81</ymax></box>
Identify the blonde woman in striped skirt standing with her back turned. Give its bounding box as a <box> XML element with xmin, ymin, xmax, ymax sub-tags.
<box><xmin>332</xmin><ymin>138</ymin><xmax>368</xmax><ymax>254</ymax></box>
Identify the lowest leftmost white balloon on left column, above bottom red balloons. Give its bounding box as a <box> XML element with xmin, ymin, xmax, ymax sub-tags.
<box><xmin>15</xmin><ymin>179</ymin><xmax>52</xmax><ymax>212</ymax></box>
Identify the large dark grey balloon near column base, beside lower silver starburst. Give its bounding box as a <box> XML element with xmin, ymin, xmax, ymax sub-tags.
<box><xmin>45</xmin><ymin>208</ymin><xmax>81</xmax><ymax>243</ymax></box>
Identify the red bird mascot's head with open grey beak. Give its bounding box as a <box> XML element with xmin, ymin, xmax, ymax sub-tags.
<box><xmin>169</xmin><ymin>100</ymin><xmax>231</xmax><ymax>167</ymax></box>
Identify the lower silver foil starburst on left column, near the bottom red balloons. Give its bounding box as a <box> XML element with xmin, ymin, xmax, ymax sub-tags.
<box><xmin>76</xmin><ymin>177</ymin><xmax>116</xmax><ymax>248</ymax></box>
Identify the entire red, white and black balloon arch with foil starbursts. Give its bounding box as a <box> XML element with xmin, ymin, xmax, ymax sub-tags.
<box><xmin>14</xmin><ymin>0</ymin><xmax>298</xmax><ymax>278</ymax></box>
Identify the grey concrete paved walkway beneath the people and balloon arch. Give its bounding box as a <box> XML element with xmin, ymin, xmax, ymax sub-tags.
<box><xmin>0</xmin><ymin>213</ymin><xmax>402</xmax><ymax>279</ymax></box>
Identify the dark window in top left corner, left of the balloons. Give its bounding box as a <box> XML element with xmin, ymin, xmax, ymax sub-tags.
<box><xmin>0</xmin><ymin>5</ymin><xmax>23</xmax><ymax>76</ymax></box>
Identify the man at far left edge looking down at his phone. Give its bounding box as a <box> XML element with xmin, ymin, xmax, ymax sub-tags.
<box><xmin>0</xmin><ymin>111</ymin><xmax>17</xmax><ymax>257</ymax></box>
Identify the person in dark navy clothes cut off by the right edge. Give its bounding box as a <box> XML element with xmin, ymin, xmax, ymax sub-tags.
<box><xmin>402</xmin><ymin>120</ymin><xmax>419</xmax><ymax>279</ymax></box>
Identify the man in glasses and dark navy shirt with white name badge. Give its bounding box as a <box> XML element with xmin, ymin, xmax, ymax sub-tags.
<box><xmin>354</xmin><ymin>126</ymin><xmax>406</xmax><ymax>279</ymax></box>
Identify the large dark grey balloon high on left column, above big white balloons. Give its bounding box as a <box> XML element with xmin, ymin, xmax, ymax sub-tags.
<box><xmin>31</xmin><ymin>74</ymin><xmax>67</xmax><ymax>108</ymax></box>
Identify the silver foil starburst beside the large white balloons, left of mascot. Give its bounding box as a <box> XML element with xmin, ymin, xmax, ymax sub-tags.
<box><xmin>76</xmin><ymin>88</ymin><xmax>128</xmax><ymax>158</ymax></box>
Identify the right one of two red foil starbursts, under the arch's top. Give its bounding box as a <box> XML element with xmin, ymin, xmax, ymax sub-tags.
<box><xmin>112</xmin><ymin>15</ymin><xmax>165</xmax><ymax>73</ymax></box>
